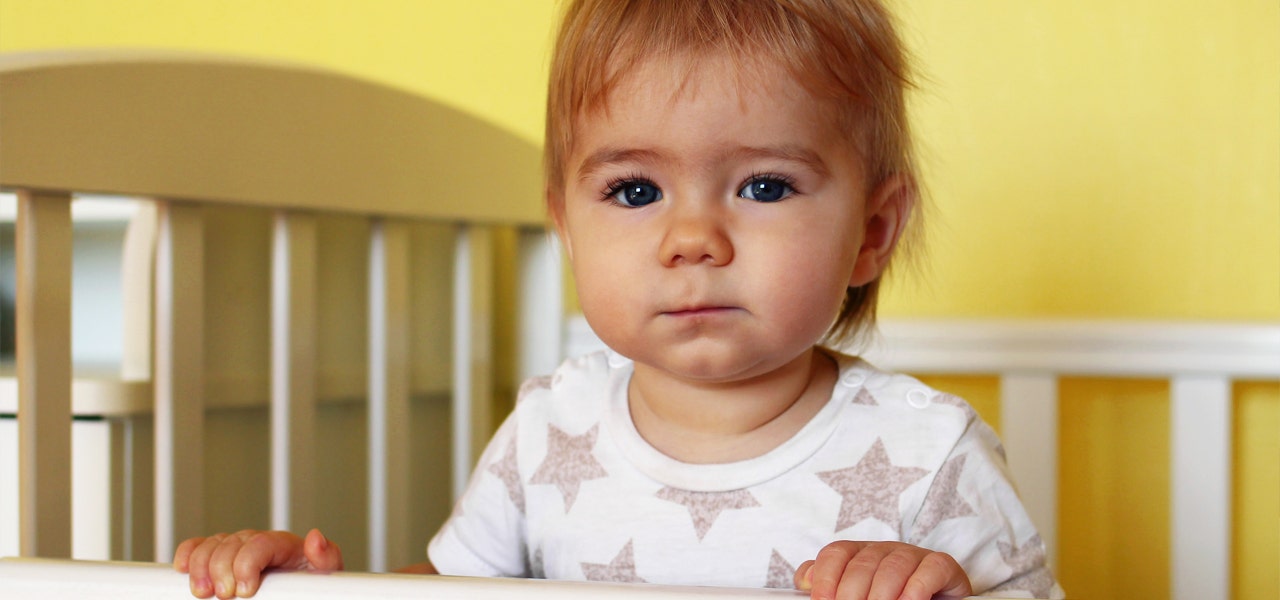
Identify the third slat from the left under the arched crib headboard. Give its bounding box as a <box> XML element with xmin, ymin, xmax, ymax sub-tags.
<box><xmin>271</xmin><ymin>210</ymin><xmax>316</xmax><ymax>531</ymax></box>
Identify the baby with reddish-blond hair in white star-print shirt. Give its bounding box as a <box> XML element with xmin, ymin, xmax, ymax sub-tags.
<box><xmin>174</xmin><ymin>0</ymin><xmax>1061</xmax><ymax>600</ymax></box>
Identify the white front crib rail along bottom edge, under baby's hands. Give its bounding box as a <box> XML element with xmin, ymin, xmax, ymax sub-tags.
<box><xmin>0</xmin><ymin>559</ymin><xmax>809</xmax><ymax>600</ymax></box>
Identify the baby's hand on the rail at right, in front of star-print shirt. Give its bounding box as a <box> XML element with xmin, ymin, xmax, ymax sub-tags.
<box><xmin>795</xmin><ymin>541</ymin><xmax>973</xmax><ymax>600</ymax></box>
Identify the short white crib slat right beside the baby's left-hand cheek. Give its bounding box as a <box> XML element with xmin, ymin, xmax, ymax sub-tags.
<box><xmin>516</xmin><ymin>229</ymin><xmax>564</xmax><ymax>381</ymax></box>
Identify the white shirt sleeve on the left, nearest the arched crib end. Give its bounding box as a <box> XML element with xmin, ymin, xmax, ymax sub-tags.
<box><xmin>428</xmin><ymin>411</ymin><xmax>530</xmax><ymax>577</ymax></box>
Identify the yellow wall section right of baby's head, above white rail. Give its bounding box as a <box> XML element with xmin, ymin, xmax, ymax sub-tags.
<box><xmin>884</xmin><ymin>0</ymin><xmax>1280</xmax><ymax>321</ymax></box>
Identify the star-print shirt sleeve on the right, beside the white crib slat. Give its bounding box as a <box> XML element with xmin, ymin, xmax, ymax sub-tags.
<box><xmin>909</xmin><ymin>416</ymin><xmax>1064</xmax><ymax>597</ymax></box>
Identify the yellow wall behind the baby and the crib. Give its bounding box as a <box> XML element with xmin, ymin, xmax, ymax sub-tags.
<box><xmin>0</xmin><ymin>0</ymin><xmax>1280</xmax><ymax>599</ymax></box>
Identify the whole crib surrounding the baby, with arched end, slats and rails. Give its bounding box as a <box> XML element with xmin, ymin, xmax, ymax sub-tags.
<box><xmin>0</xmin><ymin>51</ymin><xmax>1280</xmax><ymax>599</ymax></box>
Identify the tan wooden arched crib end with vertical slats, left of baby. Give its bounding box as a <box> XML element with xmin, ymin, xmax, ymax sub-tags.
<box><xmin>0</xmin><ymin>50</ymin><xmax>563</xmax><ymax>569</ymax></box>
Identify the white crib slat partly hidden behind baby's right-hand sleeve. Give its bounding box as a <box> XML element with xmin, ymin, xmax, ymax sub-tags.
<box><xmin>1000</xmin><ymin>374</ymin><xmax>1059</xmax><ymax>568</ymax></box>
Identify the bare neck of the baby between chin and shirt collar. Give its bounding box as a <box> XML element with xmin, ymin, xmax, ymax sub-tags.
<box><xmin>627</xmin><ymin>348</ymin><xmax>837</xmax><ymax>464</ymax></box>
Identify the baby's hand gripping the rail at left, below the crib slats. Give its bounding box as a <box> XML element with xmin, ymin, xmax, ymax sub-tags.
<box><xmin>173</xmin><ymin>530</ymin><xmax>342</xmax><ymax>599</ymax></box>
